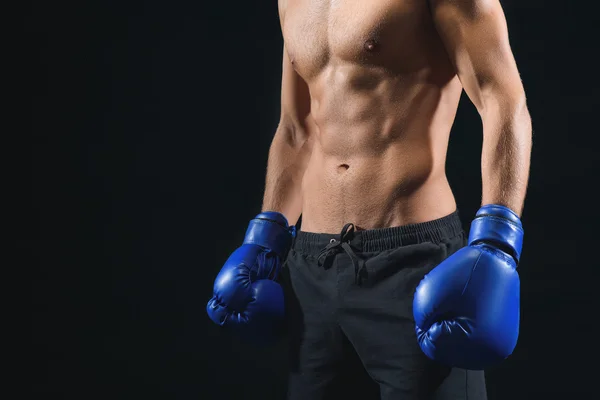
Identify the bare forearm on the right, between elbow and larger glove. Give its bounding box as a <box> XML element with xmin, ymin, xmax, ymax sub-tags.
<box><xmin>481</xmin><ymin>100</ymin><xmax>532</xmax><ymax>215</ymax></box>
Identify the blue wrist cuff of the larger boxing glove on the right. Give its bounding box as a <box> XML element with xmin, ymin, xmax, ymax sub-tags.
<box><xmin>469</xmin><ymin>204</ymin><xmax>523</xmax><ymax>262</ymax></box>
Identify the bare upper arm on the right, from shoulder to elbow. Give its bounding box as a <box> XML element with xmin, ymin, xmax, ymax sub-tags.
<box><xmin>430</xmin><ymin>0</ymin><xmax>525</xmax><ymax>111</ymax></box>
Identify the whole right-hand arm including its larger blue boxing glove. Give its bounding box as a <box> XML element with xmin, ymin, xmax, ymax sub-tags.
<box><xmin>413</xmin><ymin>0</ymin><xmax>531</xmax><ymax>369</ymax></box>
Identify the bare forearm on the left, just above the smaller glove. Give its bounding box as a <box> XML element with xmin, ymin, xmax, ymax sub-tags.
<box><xmin>262</xmin><ymin>127</ymin><xmax>311</xmax><ymax>225</ymax></box>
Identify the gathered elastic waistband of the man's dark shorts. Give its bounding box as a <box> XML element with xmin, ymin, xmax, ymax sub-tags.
<box><xmin>292</xmin><ymin>210</ymin><xmax>463</xmax><ymax>254</ymax></box>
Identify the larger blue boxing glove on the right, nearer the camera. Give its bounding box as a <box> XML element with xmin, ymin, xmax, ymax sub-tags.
<box><xmin>413</xmin><ymin>205</ymin><xmax>523</xmax><ymax>370</ymax></box>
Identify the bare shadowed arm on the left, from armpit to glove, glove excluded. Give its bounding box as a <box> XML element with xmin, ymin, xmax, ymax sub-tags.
<box><xmin>262</xmin><ymin>46</ymin><xmax>314</xmax><ymax>225</ymax></box>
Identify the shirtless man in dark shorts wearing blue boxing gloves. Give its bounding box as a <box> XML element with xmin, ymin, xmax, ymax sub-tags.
<box><xmin>207</xmin><ymin>0</ymin><xmax>531</xmax><ymax>400</ymax></box>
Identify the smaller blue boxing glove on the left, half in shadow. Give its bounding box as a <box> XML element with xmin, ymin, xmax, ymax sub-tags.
<box><xmin>206</xmin><ymin>211</ymin><xmax>295</xmax><ymax>344</ymax></box>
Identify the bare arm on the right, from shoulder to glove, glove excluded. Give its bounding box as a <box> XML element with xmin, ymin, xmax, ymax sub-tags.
<box><xmin>429</xmin><ymin>0</ymin><xmax>532</xmax><ymax>215</ymax></box>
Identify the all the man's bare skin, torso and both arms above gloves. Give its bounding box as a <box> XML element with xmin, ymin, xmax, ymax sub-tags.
<box><xmin>263</xmin><ymin>0</ymin><xmax>531</xmax><ymax>233</ymax></box>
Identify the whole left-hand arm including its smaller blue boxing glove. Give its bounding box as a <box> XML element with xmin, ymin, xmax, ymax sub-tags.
<box><xmin>206</xmin><ymin>10</ymin><xmax>315</xmax><ymax>343</ymax></box>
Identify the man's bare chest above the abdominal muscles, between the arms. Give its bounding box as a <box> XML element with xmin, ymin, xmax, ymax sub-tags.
<box><xmin>283</xmin><ymin>0</ymin><xmax>432</xmax><ymax>79</ymax></box>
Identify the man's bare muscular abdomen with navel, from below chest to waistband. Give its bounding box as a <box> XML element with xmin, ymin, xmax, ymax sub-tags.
<box><xmin>302</xmin><ymin>65</ymin><xmax>462</xmax><ymax>233</ymax></box>
